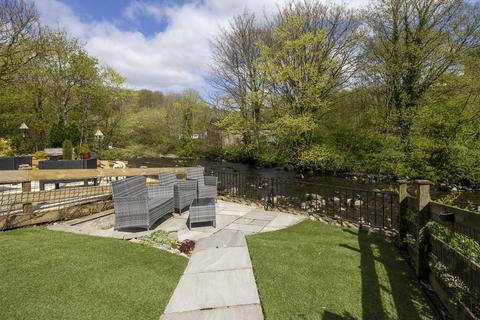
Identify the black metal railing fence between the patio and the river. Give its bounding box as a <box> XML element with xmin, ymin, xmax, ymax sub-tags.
<box><xmin>213</xmin><ymin>172</ymin><xmax>398</xmax><ymax>230</ymax></box>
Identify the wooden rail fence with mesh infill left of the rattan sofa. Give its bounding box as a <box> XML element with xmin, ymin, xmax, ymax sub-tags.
<box><xmin>0</xmin><ymin>168</ymin><xmax>186</xmax><ymax>230</ymax></box>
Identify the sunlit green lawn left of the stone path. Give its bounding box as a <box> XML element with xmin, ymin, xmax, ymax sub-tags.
<box><xmin>0</xmin><ymin>228</ymin><xmax>187</xmax><ymax>320</ymax></box>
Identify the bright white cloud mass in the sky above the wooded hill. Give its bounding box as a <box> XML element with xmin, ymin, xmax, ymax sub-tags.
<box><xmin>35</xmin><ymin>0</ymin><xmax>365</xmax><ymax>92</ymax></box>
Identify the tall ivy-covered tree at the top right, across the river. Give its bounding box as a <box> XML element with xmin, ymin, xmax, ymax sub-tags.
<box><xmin>363</xmin><ymin>0</ymin><xmax>480</xmax><ymax>149</ymax></box>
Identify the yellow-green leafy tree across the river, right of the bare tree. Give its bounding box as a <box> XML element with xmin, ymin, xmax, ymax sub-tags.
<box><xmin>259</xmin><ymin>14</ymin><xmax>336</xmax><ymax>162</ymax></box>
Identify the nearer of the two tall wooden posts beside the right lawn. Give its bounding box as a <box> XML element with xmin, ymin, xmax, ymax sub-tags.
<box><xmin>415</xmin><ymin>180</ymin><xmax>431</xmax><ymax>279</ymax></box>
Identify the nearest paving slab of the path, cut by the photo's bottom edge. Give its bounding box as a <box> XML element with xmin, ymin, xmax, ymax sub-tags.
<box><xmin>160</xmin><ymin>304</ymin><xmax>263</xmax><ymax>320</ymax></box>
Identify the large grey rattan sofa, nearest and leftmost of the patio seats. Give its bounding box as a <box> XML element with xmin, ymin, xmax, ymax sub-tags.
<box><xmin>112</xmin><ymin>176</ymin><xmax>174</xmax><ymax>230</ymax></box>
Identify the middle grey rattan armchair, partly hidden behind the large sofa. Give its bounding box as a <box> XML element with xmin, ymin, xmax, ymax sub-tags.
<box><xmin>158</xmin><ymin>172</ymin><xmax>197</xmax><ymax>212</ymax></box>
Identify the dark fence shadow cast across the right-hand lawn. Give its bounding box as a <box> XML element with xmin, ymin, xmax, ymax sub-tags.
<box><xmin>340</xmin><ymin>229</ymin><xmax>421</xmax><ymax>319</ymax></box>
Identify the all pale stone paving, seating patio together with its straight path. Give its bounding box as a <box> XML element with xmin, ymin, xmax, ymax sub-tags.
<box><xmin>48</xmin><ymin>200</ymin><xmax>305</xmax><ymax>320</ymax></box>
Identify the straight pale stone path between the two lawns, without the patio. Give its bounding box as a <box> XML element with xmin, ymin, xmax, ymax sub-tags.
<box><xmin>160</xmin><ymin>229</ymin><xmax>263</xmax><ymax>320</ymax></box>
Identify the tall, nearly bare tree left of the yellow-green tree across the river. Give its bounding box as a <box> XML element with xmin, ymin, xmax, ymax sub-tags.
<box><xmin>211</xmin><ymin>11</ymin><xmax>265</xmax><ymax>157</ymax></box>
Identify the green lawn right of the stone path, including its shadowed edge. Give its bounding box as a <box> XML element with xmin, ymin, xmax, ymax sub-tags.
<box><xmin>247</xmin><ymin>221</ymin><xmax>435</xmax><ymax>320</ymax></box>
